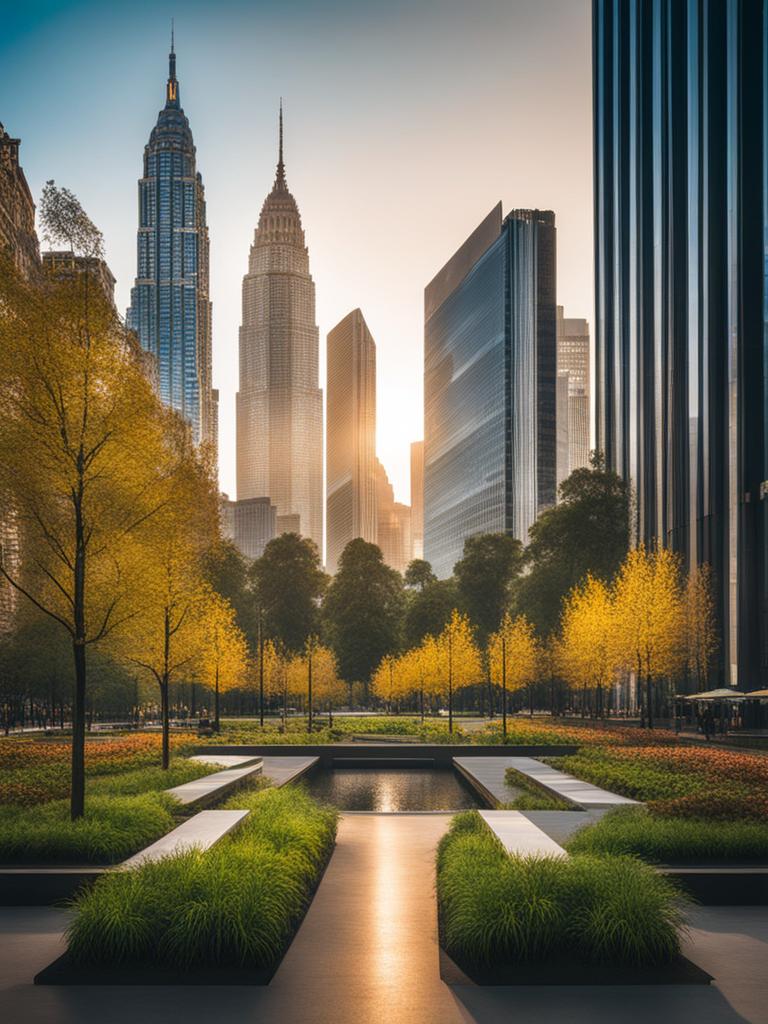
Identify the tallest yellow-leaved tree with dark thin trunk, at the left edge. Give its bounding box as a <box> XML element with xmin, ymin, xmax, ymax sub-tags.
<box><xmin>0</xmin><ymin>235</ymin><xmax>169</xmax><ymax>819</ymax></box>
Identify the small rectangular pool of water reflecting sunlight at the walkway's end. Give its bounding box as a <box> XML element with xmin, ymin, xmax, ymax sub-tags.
<box><xmin>307</xmin><ymin>768</ymin><xmax>482</xmax><ymax>813</ymax></box>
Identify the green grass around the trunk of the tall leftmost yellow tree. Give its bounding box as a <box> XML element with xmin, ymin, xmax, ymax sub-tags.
<box><xmin>0</xmin><ymin>793</ymin><xmax>176</xmax><ymax>864</ymax></box>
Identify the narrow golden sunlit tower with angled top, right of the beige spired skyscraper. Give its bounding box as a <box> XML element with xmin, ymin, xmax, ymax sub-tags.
<box><xmin>326</xmin><ymin>309</ymin><xmax>376</xmax><ymax>572</ymax></box>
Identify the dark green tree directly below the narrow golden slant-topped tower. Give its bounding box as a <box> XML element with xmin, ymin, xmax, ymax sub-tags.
<box><xmin>323</xmin><ymin>538</ymin><xmax>403</xmax><ymax>683</ymax></box>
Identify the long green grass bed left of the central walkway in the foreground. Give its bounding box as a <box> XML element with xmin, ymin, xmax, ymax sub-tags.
<box><xmin>68</xmin><ymin>786</ymin><xmax>338</xmax><ymax>970</ymax></box>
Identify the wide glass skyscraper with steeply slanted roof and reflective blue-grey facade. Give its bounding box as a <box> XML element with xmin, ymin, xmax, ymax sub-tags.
<box><xmin>424</xmin><ymin>203</ymin><xmax>556</xmax><ymax>578</ymax></box>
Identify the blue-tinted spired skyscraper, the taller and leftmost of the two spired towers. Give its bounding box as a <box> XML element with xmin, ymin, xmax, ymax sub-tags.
<box><xmin>126</xmin><ymin>40</ymin><xmax>218</xmax><ymax>444</ymax></box>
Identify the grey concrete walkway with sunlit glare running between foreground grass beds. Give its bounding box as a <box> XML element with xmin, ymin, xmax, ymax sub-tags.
<box><xmin>0</xmin><ymin>814</ymin><xmax>768</xmax><ymax>1024</ymax></box>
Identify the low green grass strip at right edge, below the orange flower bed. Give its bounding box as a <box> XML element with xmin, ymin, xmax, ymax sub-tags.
<box><xmin>565</xmin><ymin>807</ymin><xmax>768</xmax><ymax>864</ymax></box>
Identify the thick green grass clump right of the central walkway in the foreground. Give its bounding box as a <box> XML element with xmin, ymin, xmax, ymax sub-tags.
<box><xmin>437</xmin><ymin>811</ymin><xmax>683</xmax><ymax>967</ymax></box>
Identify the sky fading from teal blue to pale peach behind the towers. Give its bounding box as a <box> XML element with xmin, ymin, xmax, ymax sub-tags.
<box><xmin>0</xmin><ymin>0</ymin><xmax>594</xmax><ymax>502</ymax></box>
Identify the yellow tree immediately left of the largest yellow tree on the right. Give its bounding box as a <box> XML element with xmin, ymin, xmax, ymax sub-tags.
<box><xmin>558</xmin><ymin>575</ymin><xmax>618</xmax><ymax>714</ymax></box>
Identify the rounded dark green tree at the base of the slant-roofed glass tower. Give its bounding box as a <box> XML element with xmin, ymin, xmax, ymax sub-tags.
<box><xmin>454</xmin><ymin>534</ymin><xmax>522</xmax><ymax>642</ymax></box>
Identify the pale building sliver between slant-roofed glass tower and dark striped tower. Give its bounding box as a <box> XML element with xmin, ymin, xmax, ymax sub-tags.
<box><xmin>557</xmin><ymin>306</ymin><xmax>591</xmax><ymax>483</ymax></box>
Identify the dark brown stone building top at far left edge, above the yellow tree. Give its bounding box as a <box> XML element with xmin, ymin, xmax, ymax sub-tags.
<box><xmin>0</xmin><ymin>124</ymin><xmax>40</xmax><ymax>278</ymax></box>
